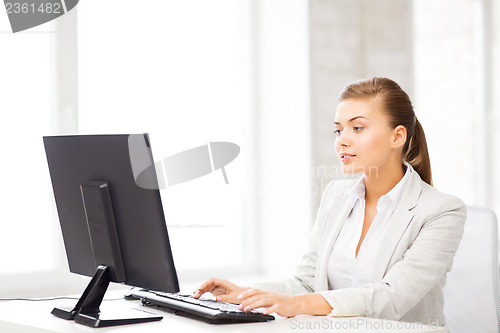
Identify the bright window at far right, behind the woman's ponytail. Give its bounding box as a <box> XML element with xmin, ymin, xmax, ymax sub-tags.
<box><xmin>413</xmin><ymin>0</ymin><xmax>491</xmax><ymax>205</ymax></box>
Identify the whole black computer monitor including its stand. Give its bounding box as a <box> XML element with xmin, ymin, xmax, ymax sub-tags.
<box><xmin>43</xmin><ymin>134</ymin><xmax>179</xmax><ymax>327</ymax></box>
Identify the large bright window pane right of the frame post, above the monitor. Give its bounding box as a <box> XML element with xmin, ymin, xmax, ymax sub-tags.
<box><xmin>78</xmin><ymin>0</ymin><xmax>251</xmax><ymax>274</ymax></box>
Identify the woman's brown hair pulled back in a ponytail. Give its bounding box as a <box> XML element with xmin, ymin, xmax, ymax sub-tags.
<box><xmin>339</xmin><ymin>77</ymin><xmax>432</xmax><ymax>186</ymax></box>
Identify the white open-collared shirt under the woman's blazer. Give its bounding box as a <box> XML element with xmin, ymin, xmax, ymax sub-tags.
<box><xmin>328</xmin><ymin>162</ymin><xmax>413</xmax><ymax>290</ymax></box>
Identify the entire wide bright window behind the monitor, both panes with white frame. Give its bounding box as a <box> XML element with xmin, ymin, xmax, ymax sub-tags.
<box><xmin>0</xmin><ymin>0</ymin><xmax>311</xmax><ymax>296</ymax></box>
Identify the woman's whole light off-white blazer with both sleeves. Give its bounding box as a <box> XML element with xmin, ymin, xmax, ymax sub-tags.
<box><xmin>254</xmin><ymin>166</ymin><xmax>467</xmax><ymax>326</ymax></box>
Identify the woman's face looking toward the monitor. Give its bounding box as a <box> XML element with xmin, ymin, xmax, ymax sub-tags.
<box><xmin>335</xmin><ymin>97</ymin><xmax>400</xmax><ymax>176</ymax></box>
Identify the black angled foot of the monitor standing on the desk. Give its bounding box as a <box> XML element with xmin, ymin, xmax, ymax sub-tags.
<box><xmin>52</xmin><ymin>265</ymin><xmax>163</xmax><ymax>327</ymax></box>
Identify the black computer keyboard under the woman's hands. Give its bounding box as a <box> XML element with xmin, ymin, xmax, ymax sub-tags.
<box><xmin>130</xmin><ymin>289</ymin><xmax>274</xmax><ymax>324</ymax></box>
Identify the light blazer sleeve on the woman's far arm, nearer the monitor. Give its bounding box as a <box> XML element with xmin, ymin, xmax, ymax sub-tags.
<box><xmin>252</xmin><ymin>181</ymin><xmax>335</xmax><ymax>294</ymax></box>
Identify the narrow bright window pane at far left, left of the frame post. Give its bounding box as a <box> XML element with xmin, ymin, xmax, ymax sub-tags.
<box><xmin>0</xmin><ymin>15</ymin><xmax>56</xmax><ymax>276</ymax></box>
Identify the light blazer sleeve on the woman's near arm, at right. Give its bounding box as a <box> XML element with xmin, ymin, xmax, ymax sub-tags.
<box><xmin>321</xmin><ymin>195</ymin><xmax>467</xmax><ymax>320</ymax></box>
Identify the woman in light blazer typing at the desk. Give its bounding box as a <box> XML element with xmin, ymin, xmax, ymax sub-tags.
<box><xmin>193</xmin><ymin>78</ymin><xmax>466</xmax><ymax>325</ymax></box>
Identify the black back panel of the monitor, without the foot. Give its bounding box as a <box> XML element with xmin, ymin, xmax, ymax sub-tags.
<box><xmin>43</xmin><ymin>134</ymin><xmax>179</xmax><ymax>292</ymax></box>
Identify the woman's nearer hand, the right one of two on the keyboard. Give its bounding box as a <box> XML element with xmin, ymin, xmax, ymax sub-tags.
<box><xmin>237</xmin><ymin>289</ymin><xmax>332</xmax><ymax>317</ymax></box>
